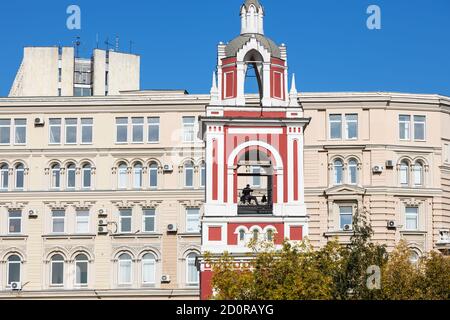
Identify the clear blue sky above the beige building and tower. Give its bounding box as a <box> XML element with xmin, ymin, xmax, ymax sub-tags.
<box><xmin>0</xmin><ymin>0</ymin><xmax>450</xmax><ymax>96</ymax></box>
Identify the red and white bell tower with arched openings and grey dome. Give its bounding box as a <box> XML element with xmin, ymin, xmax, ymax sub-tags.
<box><xmin>200</xmin><ymin>0</ymin><xmax>310</xmax><ymax>299</ymax></box>
